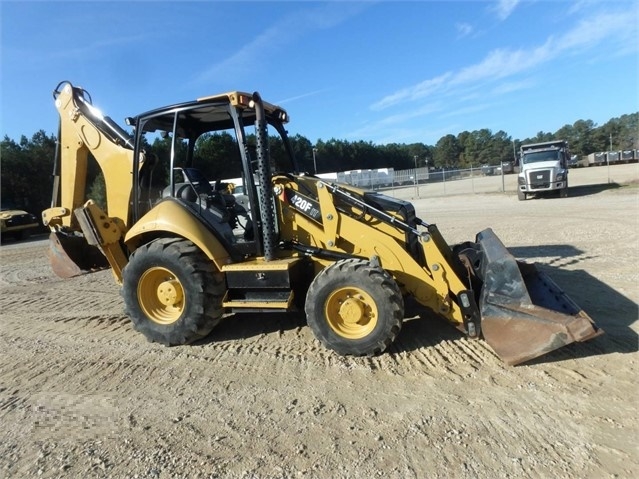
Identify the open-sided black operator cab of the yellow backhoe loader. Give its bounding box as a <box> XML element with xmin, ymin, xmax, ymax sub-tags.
<box><xmin>127</xmin><ymin>92</ymin><xmax>297</xmax><ymax>260</ymax></box>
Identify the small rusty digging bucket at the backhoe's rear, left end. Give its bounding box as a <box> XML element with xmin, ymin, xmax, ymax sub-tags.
<box><xmin>49</xmin><ymin>232</ymin><xmax>109</xmax><ymax>278</ymax></box>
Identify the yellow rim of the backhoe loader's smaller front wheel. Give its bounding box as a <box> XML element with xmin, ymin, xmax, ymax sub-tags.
<box><xmin>324</xmin><ymin>287</ymin><xmax>378</xmax><ymax>339</ymax></box>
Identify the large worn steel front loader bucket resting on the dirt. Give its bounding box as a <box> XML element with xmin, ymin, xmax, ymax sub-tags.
<box><xmin>477</xmin><ymin>229</ymin><xmax>603</xmax><ymax>365</ymax></box>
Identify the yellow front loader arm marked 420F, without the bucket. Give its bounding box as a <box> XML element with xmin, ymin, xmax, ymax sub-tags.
<box><xmin>276</xmin><ymin>177</ymin><xmax>479</xmax><ymax>336</ymax></box>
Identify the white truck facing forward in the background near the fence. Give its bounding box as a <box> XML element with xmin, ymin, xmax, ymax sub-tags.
<box><xmin>517</xmin><ymin>140</ymin><xmax>570</xmax><ymax>200</ymax></box>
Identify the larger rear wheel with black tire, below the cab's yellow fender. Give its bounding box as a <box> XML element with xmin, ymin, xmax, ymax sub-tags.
<box><xmin>122</xmin><ymin>238</ymin><xmax>225</xmax><ymax>346</ymax></box>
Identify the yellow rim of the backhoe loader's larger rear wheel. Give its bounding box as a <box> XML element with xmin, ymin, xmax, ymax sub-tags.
<box><xmin>138</xmin><ymin>266</ymin><xmax>185</xmax><ymax>325</ymax></box>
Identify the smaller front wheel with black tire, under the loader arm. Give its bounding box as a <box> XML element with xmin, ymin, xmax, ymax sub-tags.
<box><xmin>305</xmin><ymin>259</ymin><xmax>404</xmax><ymax>356</ymax></box>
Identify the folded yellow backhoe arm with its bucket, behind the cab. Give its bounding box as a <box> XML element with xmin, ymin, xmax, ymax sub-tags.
<box><xmin>42</xmin><ymin>82</ymin><xmax>133</xmax><ymax>281</ymax></box>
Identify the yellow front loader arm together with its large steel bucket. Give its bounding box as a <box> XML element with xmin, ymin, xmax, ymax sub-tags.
<box><xmin>274</xmin><ymin>177</ymin><xmax>603</xmax><ymax>365</ymax></box>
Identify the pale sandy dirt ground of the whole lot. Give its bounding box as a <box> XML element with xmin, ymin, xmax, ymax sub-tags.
<box><xmin>0</xmin><ymin>164</ymin><xmax>639</xmax><ymax>478</ymax></box>
